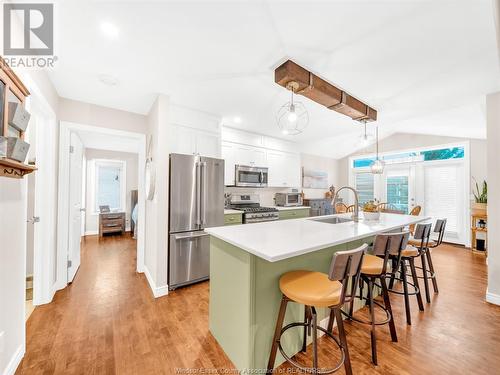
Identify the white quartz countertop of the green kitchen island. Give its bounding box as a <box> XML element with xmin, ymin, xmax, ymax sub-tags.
<box><xmin>205</xmin><ymin>213</ymin><xmax>430</xmax><ymax>262</ymax></box>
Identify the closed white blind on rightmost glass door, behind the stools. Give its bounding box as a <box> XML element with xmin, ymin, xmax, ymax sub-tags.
<box><xmin>424</xmin><ymin>164</ymin><xmax>464</xmax><ymax>242</ymax></box>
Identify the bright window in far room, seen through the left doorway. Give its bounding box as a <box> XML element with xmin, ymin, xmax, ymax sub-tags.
<box><xmin>94</xmin><ymin>160</ymin><xmax>126</xmax><ymax>212</ymax></box>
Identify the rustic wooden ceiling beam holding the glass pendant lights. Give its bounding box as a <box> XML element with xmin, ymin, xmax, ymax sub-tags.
<box><xmin>274</xmin><ymin>60</ymin><xmax>377</xmax><ymax>122</ymax></box>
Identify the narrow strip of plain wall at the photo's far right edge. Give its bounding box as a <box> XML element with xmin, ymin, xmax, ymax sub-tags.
<box><xmin>486</xmin><ymin>92</ymin><xmax>500</xmax><ymax>305</ymax></box>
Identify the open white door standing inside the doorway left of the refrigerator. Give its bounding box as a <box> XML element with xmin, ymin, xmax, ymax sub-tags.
<box><xmin>68</xmin><ymin>133</ymin><xmax>83</xmax><ymax>283</ymax></box>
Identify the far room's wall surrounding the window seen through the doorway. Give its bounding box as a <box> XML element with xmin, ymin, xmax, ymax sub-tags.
<box><xmin>85</xmin><ymin>148</ymin><xmax>138</xmax><ymax>235</ymax></box>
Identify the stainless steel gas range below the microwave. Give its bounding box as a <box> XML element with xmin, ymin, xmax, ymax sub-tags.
<box><xmin>229</xmin><ymin>194</ymin><xmax>279</xmax><ymax>224</ymax></box>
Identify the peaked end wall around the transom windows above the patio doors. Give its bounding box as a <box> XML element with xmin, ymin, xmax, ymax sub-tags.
<box><xmin>339</xmin><ymin>133</ymin><xmax>487</xmax><ymax>192</ymax></box>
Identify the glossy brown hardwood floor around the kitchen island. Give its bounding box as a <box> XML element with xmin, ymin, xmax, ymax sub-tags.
<box><xmin>16</xmin><ymin>236</ymin><xmax>500</xmax><ymax>375</ymax></box>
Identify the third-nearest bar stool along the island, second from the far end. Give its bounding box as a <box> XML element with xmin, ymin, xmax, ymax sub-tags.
<box><xmin>389</xmin><ymin>224</ymin><xmax>431</xmax><ymax>325</ymax></box>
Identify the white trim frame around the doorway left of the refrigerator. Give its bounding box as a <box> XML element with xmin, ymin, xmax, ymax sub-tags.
<box><xmin>57</xmin><ymin>121</ymin><xmax>146</xmax><ymax>289</ymax></box>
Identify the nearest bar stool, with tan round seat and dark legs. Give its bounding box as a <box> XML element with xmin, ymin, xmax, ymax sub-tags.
<box><xmin>267</xmin><ymin>244</ymin><xmax>368</xmax><ymax>375</ymax></box>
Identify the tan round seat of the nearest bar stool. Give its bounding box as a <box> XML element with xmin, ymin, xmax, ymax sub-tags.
<box><xmin>280</xmin><ymin>271</ymin><xmax>342</xmax><ymax>307</ymax></box>
